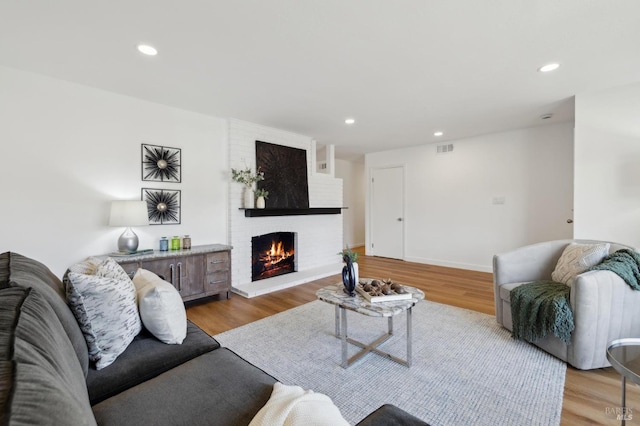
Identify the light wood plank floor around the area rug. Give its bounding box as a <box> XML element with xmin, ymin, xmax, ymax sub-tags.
<box><xmin>187</xmin><ymin>248</ymin><xmax>640</xmax><ymax>425</ymax></box>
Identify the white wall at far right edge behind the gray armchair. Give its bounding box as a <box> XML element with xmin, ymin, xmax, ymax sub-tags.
<box><xmin>574</xmin><ymin>83</ymin><xmax>640</xmax><ymax>247</ymax></box>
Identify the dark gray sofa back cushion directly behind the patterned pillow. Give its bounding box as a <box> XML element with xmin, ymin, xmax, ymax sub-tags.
<box><xmin>0</xmin><ymin>252</ymin><xmax>89</xmax><ymax>375</ymax></box>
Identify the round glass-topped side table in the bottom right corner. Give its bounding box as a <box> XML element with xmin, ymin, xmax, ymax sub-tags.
<box><xmin>607</xmin><ymin>338</ymin><xmax>640</xmax><ymax>425</ymax></box>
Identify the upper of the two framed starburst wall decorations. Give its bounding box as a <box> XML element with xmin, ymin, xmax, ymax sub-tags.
<box><xmin>142</xmin><ymin>144</ymin><xmax>182</xmax><ymax>182</ymax></box>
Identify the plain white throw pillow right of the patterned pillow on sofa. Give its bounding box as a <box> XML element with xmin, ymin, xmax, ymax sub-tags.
<box><xmin>133</xmin><ymin>268</ymin><xmax>187</xmax><ymax>345</ymax></box>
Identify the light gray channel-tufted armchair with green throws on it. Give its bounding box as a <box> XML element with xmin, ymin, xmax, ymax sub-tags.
<box><xmin>493</xmin><ymin>240</ymin><xmax>640</xmax><ymax>370</ymax></box>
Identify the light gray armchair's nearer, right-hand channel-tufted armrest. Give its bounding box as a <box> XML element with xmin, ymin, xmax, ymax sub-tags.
<box><xmin>567</xmin><ymin>271</ymin><xmax>640</xmax><ymax>369</ymax></box>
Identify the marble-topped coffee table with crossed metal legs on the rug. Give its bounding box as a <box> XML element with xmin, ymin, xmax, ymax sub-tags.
<box><xmin>316</xmin><ymin>278</ymin><xmax>424</xmax><ymax>368</ymax></box>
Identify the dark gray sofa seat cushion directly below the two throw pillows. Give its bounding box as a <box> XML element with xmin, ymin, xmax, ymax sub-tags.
<box><xmin>87</xmin><ymin>322</ymin><xmax>220</xmax><ymax>404</ymax></box>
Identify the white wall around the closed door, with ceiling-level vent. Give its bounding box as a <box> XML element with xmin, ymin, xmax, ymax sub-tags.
<box><xmin>365</xmin><ymin>123</ymin><xmax>573</xmax><ymax>271</ymax></box>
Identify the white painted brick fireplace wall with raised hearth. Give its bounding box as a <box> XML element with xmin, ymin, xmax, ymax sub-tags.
<box><xmin>228</xmin><ymin>119</ymin><xmax>342</xmax><ymax>297</ymax></box>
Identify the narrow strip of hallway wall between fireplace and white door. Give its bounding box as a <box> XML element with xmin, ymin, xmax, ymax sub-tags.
<box><xmin>336</xmin><ymin>160</ymin><xmax>365</xmax><ymax>247</ymax></box>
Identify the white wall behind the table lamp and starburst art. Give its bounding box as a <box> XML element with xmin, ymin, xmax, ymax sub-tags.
<box><xmin>0</xmin><ymin>67</ymin><xmax>228</xmax><ymax>276</ymax></box>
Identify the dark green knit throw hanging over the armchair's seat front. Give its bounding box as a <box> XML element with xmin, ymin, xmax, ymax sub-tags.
<box><xmin>510</xmin><ymin>281</ymin><xmax>574</xmax><ymax>344</ymax></box>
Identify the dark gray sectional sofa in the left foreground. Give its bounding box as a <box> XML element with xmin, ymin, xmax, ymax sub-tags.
<box><xmin>0</xmin><ymin>252</ymin><xmax>426</xmax><ymax>426</ymax></box>
